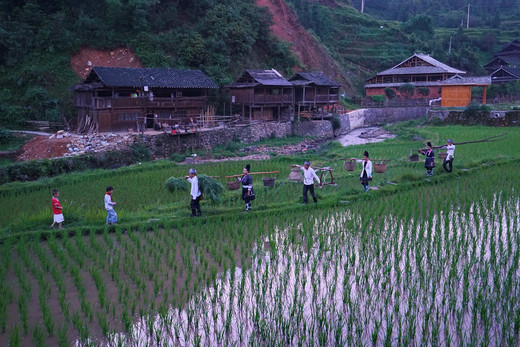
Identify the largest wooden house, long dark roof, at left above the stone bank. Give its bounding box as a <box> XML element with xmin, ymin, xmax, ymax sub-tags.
<box><xmin>73</xmin><ymin>66</ymin><xmax>218</xmax><ymax>133</ymax></box>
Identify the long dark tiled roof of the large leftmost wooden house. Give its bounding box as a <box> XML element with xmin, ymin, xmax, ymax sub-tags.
<box><xmin>84</xmin><ymin>66</ymin><xmax>218</xmax><ymax>88</ymax></box>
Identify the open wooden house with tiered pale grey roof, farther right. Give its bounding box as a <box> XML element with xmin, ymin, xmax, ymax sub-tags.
<box><xmin>365</xmin><ymin>53</ymin><xmax>466</xmax><ymax>98</ymax></box>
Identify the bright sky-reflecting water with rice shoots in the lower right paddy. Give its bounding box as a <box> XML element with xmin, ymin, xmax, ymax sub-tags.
<box><xmin>85</xmin><ymin>195</ymin><xmax>520</xmax><ymax>346</ymax></box>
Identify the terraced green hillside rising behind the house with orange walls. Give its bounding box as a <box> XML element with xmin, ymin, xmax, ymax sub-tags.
<box><xmin>287</xmin><ymin>0</ymin><xmax>520</xmax><ymax>95</ymax></box>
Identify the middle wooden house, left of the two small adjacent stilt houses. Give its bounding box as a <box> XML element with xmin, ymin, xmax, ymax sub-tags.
<box><xmin>225</xmin><ymin>69</ymin><xmax>294</xmax><ymax>120</ymax></box>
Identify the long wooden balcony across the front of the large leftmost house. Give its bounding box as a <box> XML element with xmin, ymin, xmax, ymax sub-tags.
<box><xmin>76</xmin><ymin>96</ymin><xmax>206</xmax><ymax>110</ymax></box>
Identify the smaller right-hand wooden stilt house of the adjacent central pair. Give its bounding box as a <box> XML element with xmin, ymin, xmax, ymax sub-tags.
<box><xmin>289</xmin><ymin>71</ymin><xmax>341</xmax><ymax>115</ymax></box>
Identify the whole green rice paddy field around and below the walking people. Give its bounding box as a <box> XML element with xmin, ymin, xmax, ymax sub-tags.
<box><xmin>0</xmin><ymin>128</ymin><xmax>520</xmax><ymax>346</ymax></box>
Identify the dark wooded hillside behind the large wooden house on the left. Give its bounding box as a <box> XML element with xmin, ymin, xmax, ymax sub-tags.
<box><xmin>0</xmin><ymin>0</ymin><xmax>298</xmax><ymax>126</ymax></box>
